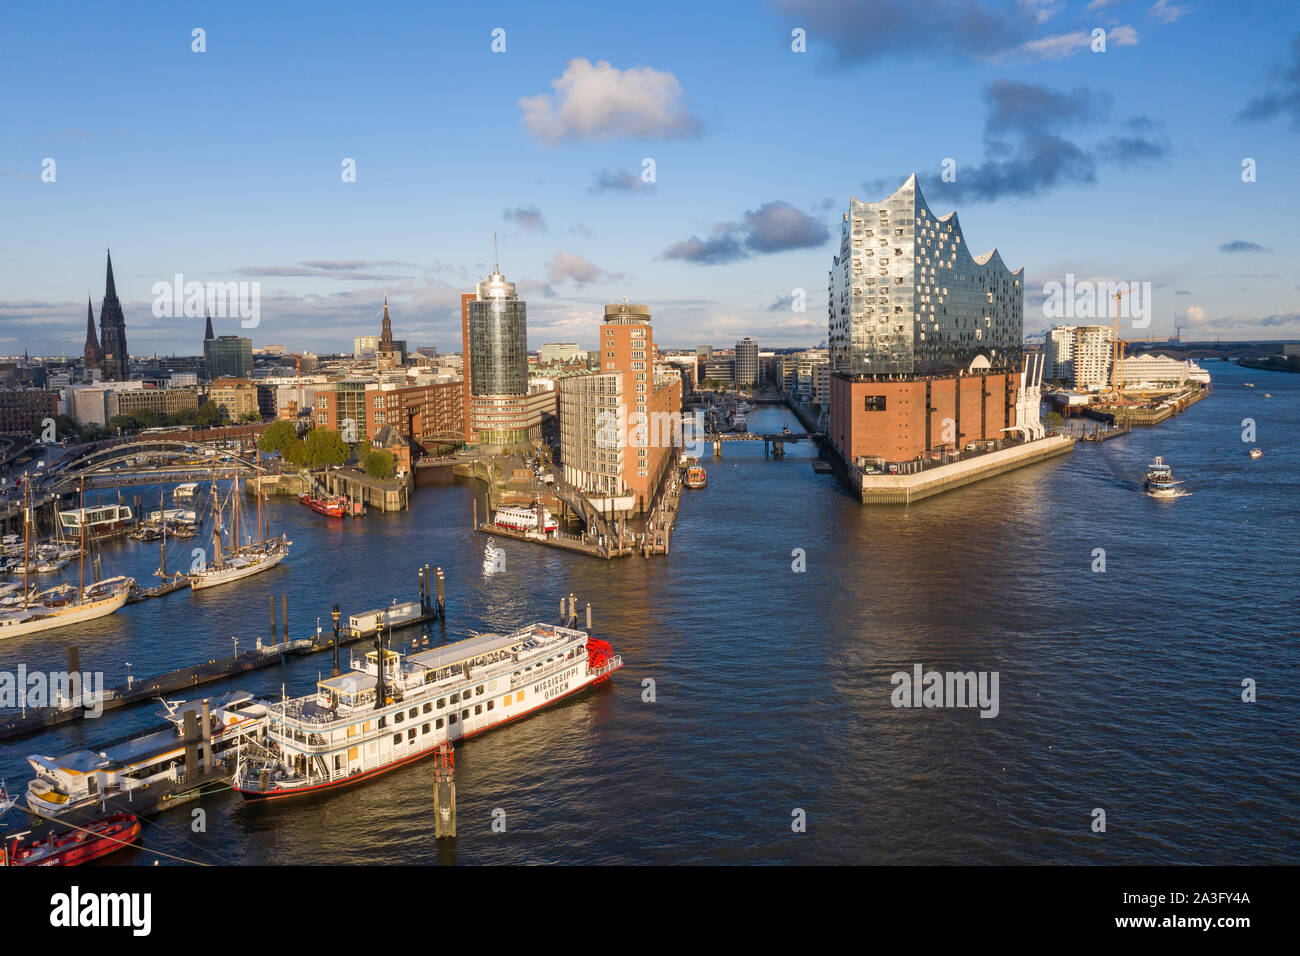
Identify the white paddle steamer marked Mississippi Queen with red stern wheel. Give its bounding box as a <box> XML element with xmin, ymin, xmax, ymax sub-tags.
<box><xmin>231</xmin><ymin>624</ymin><xmax>623</xmax><ymax>800</ymax></box>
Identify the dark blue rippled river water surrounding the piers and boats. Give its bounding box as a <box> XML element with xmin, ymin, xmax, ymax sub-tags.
<box><xmin>0</xmin><ymin>362</ymin><xmax>1300</xmax><ymax>865</ymax></box>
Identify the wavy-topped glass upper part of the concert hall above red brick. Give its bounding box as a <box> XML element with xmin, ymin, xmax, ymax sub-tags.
<box><xmin>828</xmin><ymin>176</ymin><xmax>1024</xmax><ymax>375</ymax></box>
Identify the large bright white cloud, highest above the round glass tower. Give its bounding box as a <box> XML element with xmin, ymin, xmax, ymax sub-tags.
<box><xmin>519</xmin><ymin>57</ymin><xmax>699</xmax><ymax>146</ymax></box>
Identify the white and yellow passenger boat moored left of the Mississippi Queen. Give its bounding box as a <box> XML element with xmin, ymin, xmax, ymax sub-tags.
<box><xmin>27</xmin><ymin>691</ymin><xmax>267</xmax><ymax>817</ymax></box>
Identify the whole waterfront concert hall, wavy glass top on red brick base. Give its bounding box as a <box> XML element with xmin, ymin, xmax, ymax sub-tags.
<box><xmin>827</xmin><ymin>174</ymin><xmax>1024</xmax><ymax>471</ymax></box>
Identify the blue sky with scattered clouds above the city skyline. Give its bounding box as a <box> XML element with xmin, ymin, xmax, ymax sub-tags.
<box><xmin>0</xmin><ymin>0</ymin><xmax>1300</xmax><ymax>355</ymax></box>
